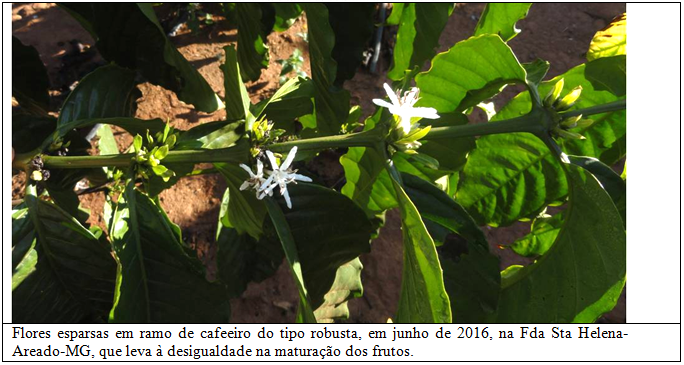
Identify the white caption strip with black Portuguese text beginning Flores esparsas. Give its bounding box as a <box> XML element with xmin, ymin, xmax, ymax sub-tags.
<box><xmin>2</xmin><ymin>323</ymin><xmax>680</xmax><ymax>361</ymax></box>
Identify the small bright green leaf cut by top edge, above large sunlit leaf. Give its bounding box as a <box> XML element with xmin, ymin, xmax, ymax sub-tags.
<box><xmin>474</xmin><ymin>3</ymin><xmax>532</xmax><ymax>42</ymax></box>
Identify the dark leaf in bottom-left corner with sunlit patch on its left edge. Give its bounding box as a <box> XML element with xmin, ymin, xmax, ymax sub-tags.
<box><xmin>12</xmin><ymin>186</ymin><xmax>116</xmax><ymax>323</ymax></box>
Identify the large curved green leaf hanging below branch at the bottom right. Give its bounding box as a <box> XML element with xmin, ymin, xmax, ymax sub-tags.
<box><xmin>496</xmin><ymin>165</ymin><xmax>626</xmax><ymax>323</ymax></box>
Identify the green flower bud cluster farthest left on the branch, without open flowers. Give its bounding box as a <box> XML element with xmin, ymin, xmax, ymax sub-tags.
<box><xmin>133</xmin><ymin>124</ymin><xmax>178</xmax><ymax>182</ymax></box>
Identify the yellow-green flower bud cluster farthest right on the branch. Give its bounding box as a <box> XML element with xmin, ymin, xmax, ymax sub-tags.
<box><xmin>544</xmin><ymin>79</ymin><xmax>594</xmax><ymax>139</ymax></box>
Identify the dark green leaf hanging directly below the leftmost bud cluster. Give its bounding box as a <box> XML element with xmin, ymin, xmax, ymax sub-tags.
<box><xmin>109</xmin><ymin>181</ymin><xmax>230</xmax><ymax>323</ymax></box>
